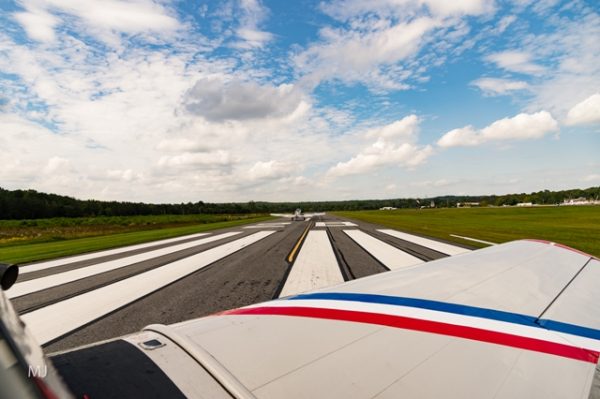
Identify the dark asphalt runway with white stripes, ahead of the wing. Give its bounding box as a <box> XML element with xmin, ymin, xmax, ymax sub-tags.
<box><xmin>7</xmin><ymin>215</ymin><xmax>476</xmax><ymax>353</ymax></box>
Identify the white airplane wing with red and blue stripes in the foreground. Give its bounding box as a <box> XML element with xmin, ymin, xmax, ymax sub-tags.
<box><xmin>43</xmin><ymin>241</ymin><xmax>600</xmax><ymax>399</ymax></box>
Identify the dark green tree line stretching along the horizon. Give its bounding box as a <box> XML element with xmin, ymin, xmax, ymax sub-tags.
<box><xmin>0</xmin><ymin>186</ymin><xmax>600</xmax><ymax>219</ymax></box>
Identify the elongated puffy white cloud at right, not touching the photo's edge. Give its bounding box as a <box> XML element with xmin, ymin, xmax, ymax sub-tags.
<box><xmin>437</xmin><ymin>111</ymin><xmax>558</xmax><ymax>147</ymax></box>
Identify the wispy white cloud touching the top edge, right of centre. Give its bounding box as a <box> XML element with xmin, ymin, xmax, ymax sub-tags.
<box><xmin>293</xmin><ymin>0</ymin><xmax>493</xmax><ymax>92</ymax></box>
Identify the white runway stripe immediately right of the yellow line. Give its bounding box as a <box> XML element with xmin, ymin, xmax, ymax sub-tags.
<box><xmin>279</xmin><ymin>231</ymin><xmax>344</xmax><ymax>297</ymax></box>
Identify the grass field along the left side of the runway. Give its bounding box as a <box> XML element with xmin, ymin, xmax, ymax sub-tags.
<box><xmin>0</xmin><ymin>214</ymin><xmax>272</xmax><ymax>263</ymax></box>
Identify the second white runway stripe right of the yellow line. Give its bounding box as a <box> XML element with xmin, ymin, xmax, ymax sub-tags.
<box><xmin>344</xmin><ymin>230</ymin><xmax>423</xmax><ymax>270</ymax></box>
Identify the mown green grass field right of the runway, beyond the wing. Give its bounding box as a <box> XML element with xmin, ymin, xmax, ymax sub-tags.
<box><xmin>334</xmin><ymin>206</ymin><xmax>600</xmax><ymax>257</ymax></box>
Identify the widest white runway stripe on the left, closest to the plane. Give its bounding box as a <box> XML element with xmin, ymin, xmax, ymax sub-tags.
<box><xmin>21</xmin><ymin>231</ymin><xmax>273</xmax><ymax>344</ymax></box>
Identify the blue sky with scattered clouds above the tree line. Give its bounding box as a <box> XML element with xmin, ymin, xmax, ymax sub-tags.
<box><xmin>0</xmin><ymin>0</ymin><xmax>600</xmax><ymax>203</ymax></box>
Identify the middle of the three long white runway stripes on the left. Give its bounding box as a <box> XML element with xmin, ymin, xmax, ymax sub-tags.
<box><xmin>6</xmin><ymin>231</ymin><xmax>240</xmax><ymax>298</ymax></box>
